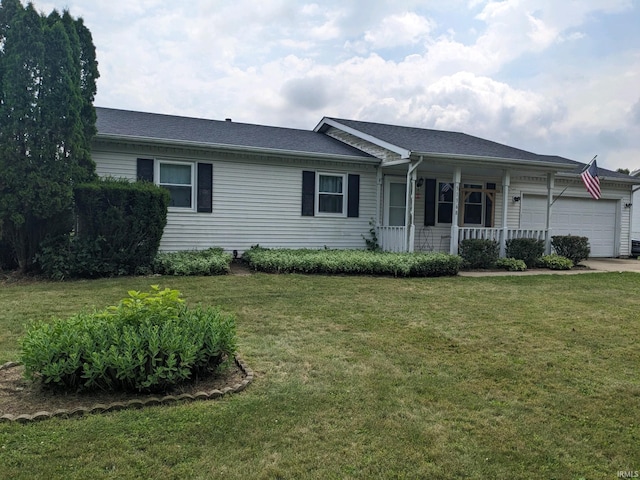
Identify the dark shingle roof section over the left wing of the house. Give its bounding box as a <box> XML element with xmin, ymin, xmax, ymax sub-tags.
<box><xmin>96</xmin><ymin>107</ymin><xmax>372</xmax><ymax>159</ymax></box>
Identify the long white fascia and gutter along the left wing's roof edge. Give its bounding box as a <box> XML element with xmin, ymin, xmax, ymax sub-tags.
<box><xmin>95</xmin><ymin>134</ymin><xmax>380</xmax><ymax>165</ymax></box>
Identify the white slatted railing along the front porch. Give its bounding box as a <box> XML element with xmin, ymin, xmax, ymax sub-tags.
<box><xmin>376</xmin><ymin>225</ymin><xmax>548</xmax><ymax>255</ymax></box>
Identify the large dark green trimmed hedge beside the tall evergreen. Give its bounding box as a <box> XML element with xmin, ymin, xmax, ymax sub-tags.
<box><xmin>37</xmin><ymin>178</ymin><xmax>169</xmax><ymax>279</ymax></box>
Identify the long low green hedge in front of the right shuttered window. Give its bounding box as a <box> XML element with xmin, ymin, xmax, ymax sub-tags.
<box><xmin>242</xmin><ymin>247</ymin><xmax>462</xmax><ymax>277</ymax></box>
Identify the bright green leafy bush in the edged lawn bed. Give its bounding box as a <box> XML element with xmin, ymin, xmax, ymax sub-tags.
<box><xmin>20</xmin><ymin>286</ymin><xmax>236</xmax><ymax>392</ymax></box>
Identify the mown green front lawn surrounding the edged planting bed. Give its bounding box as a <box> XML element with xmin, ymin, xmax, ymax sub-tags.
<box><xmin>0</xmin><ymin>273</ymin><xmax>640</xmax><ymax>479</ymax></box>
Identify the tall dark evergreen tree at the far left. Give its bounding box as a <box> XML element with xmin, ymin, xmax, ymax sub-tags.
<box><xmin>0</xmin><ymin>0</ymin><xmax>98</xmax><ymax>271</ymax></box>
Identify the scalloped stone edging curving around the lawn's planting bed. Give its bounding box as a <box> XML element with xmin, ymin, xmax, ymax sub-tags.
<box><xmin>0</xmin><ymin>356</ymin><xmax>254</xmax><ymax>423</ymax></box>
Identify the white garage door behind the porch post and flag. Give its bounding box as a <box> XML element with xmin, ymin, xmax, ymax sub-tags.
<box><xmin>520</xmin><ymin>195</ymin><xmax>617</xmax><ymax>257</ymax></box>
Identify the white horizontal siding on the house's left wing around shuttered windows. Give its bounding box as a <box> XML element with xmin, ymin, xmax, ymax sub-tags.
<box><xmin>93</xmin><ymin>144</ymin><xmax>376</xmax><ymax>253</ymax></box>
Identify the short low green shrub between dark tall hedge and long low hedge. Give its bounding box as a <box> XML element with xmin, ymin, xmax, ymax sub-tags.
<box><xmin>153</xmin><ymin>248</ymin><xmax>232</xmax><ymax>275</ymax></box>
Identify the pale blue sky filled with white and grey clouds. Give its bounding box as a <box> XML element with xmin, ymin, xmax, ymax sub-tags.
<box><xmin>28</xmin><ymin>0</ymin><xmax>640</xmax><ymax>170</ymax></box>
